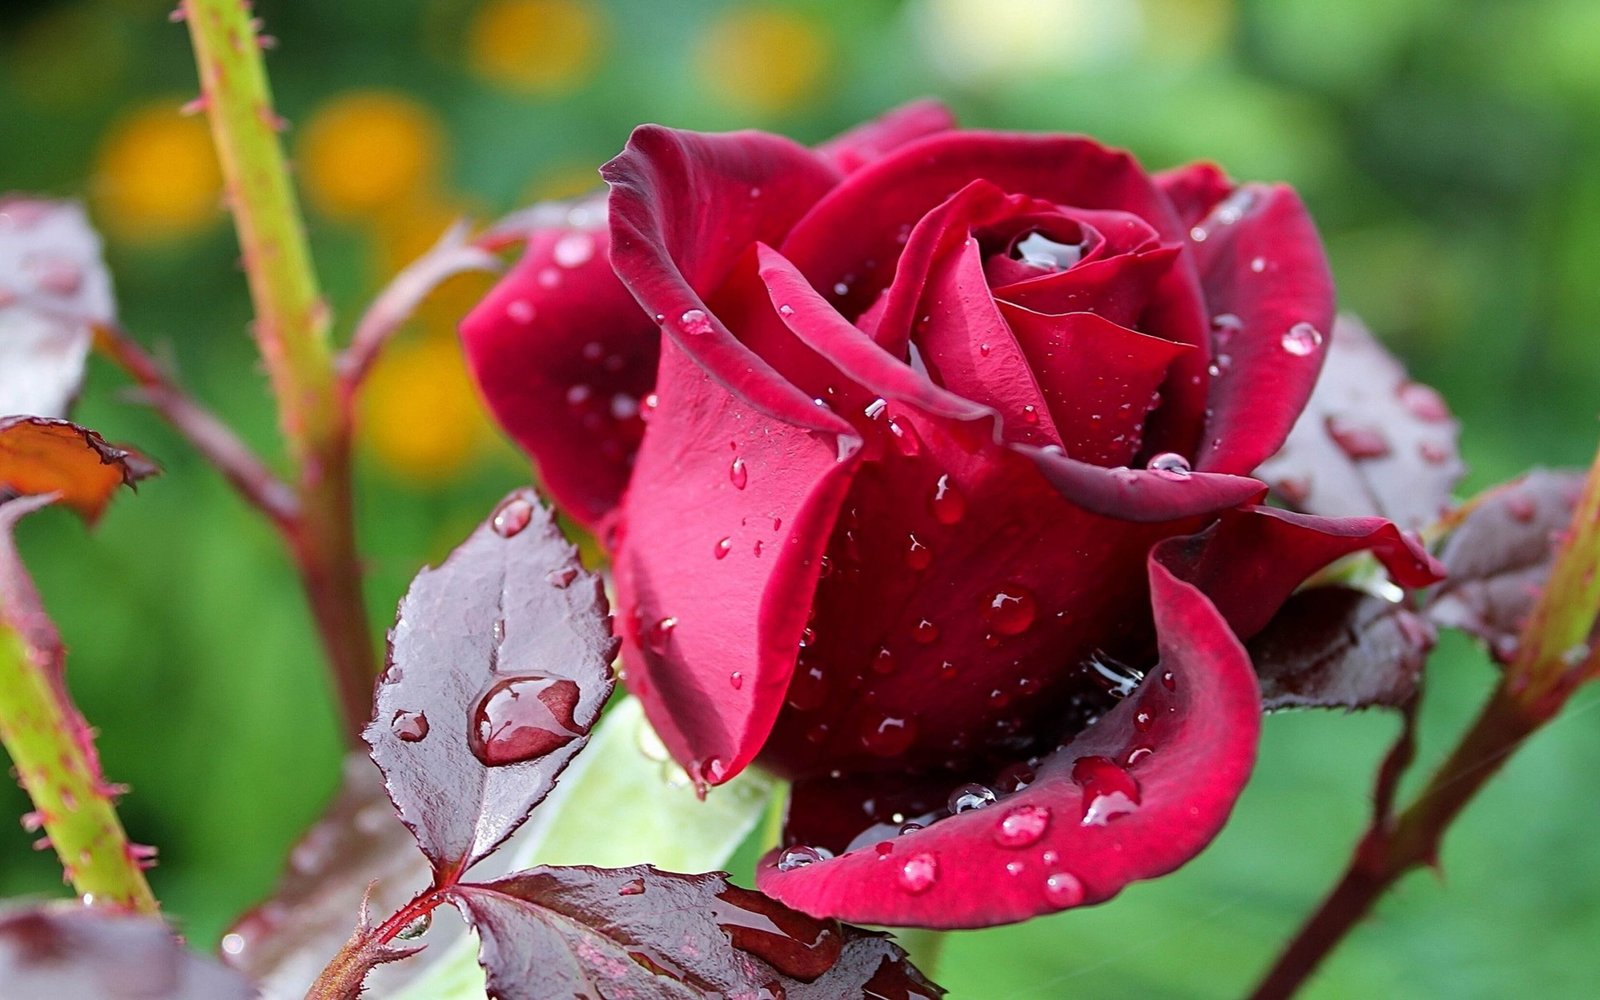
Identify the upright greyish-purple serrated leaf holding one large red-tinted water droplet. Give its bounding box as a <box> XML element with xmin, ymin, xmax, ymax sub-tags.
<box><xmin>363</xmin><ymin>490</ymin><xmax>616</xmax><ymax>885</ymax></box>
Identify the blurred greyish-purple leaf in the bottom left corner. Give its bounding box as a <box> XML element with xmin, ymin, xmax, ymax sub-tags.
<box><xmin>0</xmin><ymin>904</ymin><xmax>256</xmax><ymax>1000</ymax></box>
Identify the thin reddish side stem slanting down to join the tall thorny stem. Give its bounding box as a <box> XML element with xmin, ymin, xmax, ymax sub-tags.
<box><xmin>94</xmin><ymin>325</ymin><xmax>299</xmax><ymax>531</ymax></box>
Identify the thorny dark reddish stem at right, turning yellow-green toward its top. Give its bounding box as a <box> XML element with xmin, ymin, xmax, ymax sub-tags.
<box><xmin>1253</xmin><ymin>453</ymin><xmax>1600</xmax><ymax>1000</ymax></box>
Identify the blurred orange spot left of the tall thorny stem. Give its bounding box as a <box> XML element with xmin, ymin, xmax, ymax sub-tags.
<box><xmin>93</xmin><ymin>98</ymin><xmax>222</xmax><ymax>242</ymax></box>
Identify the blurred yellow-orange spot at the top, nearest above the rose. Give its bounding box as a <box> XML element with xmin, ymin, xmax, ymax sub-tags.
<box><xmin>694</xmin><ymin>6</ymin><xmax>829</xmax><ymax>112</ymax></box>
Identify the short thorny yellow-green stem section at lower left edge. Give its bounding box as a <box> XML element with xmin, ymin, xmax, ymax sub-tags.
<box><xmin>0</xmin><ymin>624</ymin><xmax>157</xmax><ymax>914</ymax></box>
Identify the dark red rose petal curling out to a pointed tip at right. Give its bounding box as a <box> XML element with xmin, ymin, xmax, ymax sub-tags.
<box><xmin>1166</xmin><ymin>507</ymin><xmax>1445</xmax><ymax>638</ymax></box>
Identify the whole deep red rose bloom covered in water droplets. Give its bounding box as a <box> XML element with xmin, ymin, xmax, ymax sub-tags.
<box><xmin>462</xmin><ymin>102</ymin><xmax>1437</xmax><ymax>926</ymax></box>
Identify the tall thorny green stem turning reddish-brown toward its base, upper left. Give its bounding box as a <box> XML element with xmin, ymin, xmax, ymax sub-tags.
<box><xmin>178</xmin><ymin>0</ymin><xmax>378</xmax><ymax>744</ymax></box>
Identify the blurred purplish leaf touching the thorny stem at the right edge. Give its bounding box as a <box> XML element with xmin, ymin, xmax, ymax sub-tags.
<box><xmin>1427</xmin><ymin>469</ymin><xmax>1584</xmax><ymax>661</ymax></box>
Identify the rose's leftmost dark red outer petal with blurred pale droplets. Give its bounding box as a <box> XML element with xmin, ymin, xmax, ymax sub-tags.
<box><xmin>461</xmin><ymin>222</ymin><xmax>661</xmax><ymax>528</ymax></box>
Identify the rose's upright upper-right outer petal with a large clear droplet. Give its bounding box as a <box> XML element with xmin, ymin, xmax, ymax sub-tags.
<box><xmin>1190</xmin><ymin>184</ymin><xmax>1334</xmax><ymax>474</ymax></box>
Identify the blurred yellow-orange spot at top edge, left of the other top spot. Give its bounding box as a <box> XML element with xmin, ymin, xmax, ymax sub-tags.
<box><xmin>467</xmin><ymin>0</ymin><xmax>603</xmax><ymax>93</ymax></box>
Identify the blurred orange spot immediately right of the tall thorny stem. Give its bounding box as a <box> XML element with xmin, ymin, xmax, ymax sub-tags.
<box><xmin>299</xmin><ymin>90</ymin><xmax>443</xmax><ymax>221</ymax></box>
